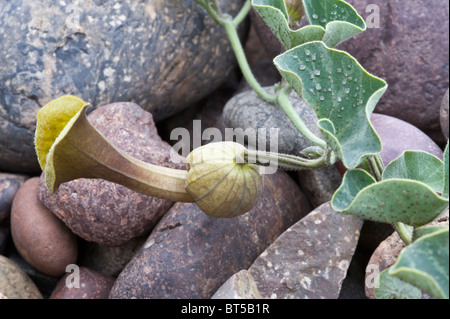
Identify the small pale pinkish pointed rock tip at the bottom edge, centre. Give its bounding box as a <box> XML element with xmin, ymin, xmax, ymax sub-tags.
<box><xmin>211</xmin><ymin>269</ymin><xmax>261</xmax><ymax>299</ymax></box>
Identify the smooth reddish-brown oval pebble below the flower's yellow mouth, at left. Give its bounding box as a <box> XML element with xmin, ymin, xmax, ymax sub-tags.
<box><xmin>11</xmin><ymin>177</ymin><xmax>78</xmax><ymax>277</ymax></box>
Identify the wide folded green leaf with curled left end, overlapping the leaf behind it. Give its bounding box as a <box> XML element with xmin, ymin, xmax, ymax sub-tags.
<box><xmin>331</xmin><ymin>170</ymin><xmax>448</xmax><ymax>227</ymax></box>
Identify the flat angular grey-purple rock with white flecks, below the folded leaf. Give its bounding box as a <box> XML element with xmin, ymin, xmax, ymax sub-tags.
<box><xmin>248</xmin><ymin>202</ymin><xmax>363</xmax><ymax>299</ymax></box>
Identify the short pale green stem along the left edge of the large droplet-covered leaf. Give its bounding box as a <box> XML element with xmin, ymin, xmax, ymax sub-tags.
<box><xmin>277</xmin><ymin>86</ymin><xmax>327</xmax><ymax>149</ymax></box>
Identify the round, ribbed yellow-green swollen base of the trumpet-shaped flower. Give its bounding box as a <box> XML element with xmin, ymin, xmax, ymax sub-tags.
<box><xmin>185</xmin><ymin>142</ymin><xmax>264</xmax><ymax>218</ymax></box>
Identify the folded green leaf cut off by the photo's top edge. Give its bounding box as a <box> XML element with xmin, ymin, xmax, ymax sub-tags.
<box><xmin>252</xmin><ymin>0</ymin><xmax>366</xmax><ymax>50</ymax></box>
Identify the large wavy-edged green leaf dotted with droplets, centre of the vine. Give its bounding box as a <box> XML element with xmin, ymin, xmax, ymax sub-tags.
<box><xmin>274</xmin><ymin>42</ymin><xmax>387</xmax><ymax>168</ymax></box>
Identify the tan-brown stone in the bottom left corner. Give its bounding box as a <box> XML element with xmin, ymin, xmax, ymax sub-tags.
<box><xmin>0</xmin><ymin>255</ymin><xmax>42</xmax><ymax>299</ymax></box>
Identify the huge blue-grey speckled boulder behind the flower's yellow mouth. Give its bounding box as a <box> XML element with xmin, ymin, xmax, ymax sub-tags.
<box><xmin>0</xmin><ymin>0</ymin><xmax>244</xmax><ymax>172</ymax></box>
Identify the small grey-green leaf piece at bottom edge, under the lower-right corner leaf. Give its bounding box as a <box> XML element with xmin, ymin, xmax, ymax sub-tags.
<box><xmin>375</xmin><ymin>269</ymin><xmax>422</xmax><ymax>299</ymax></box>
